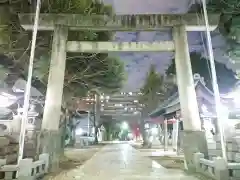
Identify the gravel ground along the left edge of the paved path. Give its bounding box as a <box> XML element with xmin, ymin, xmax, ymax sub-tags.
<box><xmin>43</xmin><ymin>145</ymin><xmax>103</xmax><ymax>180</ymax></box>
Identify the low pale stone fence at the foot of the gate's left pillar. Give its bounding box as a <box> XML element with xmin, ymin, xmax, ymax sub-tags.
<box><xmin>0</xmin><ymin>154</ymin><xmax>49</xmax><ymax>180</ymax></box>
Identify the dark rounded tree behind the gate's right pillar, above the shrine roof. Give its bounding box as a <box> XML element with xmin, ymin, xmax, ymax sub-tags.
<box><xmin>166</xmin><ymin>52</ymin><xmax>237</xmax><ymax>93</ymax></box>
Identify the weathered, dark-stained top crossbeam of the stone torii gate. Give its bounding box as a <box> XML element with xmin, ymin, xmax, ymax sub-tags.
<box><xmin>19</xmin><ymin>14</ymin><xmax>220</xmax><ymax>31</ymax></box>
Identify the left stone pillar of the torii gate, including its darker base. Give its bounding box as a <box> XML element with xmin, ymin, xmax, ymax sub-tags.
<box><xmin>42</xmin><ymin>25</ymin><xmax>68</xmax><ymax>172</ymax></box>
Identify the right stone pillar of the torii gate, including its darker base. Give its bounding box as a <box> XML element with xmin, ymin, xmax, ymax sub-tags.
<box><xmin>173</xmin><ymin>25</ymin><xmax>207</xmax><ymax>171</ymax></box>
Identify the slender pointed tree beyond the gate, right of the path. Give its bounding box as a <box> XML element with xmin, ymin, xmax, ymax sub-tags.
<box><xmin>139</xmin><ymin>65</ymin><xmax>169</xmax><ymax>146</ymax></box>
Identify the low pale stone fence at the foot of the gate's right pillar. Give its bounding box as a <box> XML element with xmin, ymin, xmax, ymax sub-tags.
<box><xmin>194</xmin><ymin>153</ymin><xmax>240</xmax><ymax>180</ymax></box>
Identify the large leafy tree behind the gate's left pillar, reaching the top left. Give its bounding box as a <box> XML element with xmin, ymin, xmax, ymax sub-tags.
<box><xmin>0</xmin><ymin>0</ymin><xmax>124</xmax><ymax>99</ymax></box>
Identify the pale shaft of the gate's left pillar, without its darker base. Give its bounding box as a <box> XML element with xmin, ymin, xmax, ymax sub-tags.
<box><xmin>42</xmin><ymin>25</ymin><xmax>68</xmax><ymax>131</ymax></box>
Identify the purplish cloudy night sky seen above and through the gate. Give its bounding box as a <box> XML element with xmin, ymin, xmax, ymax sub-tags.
<box><xmin>104</xmin><ymin>0</ymin><xmax>233</xmax><ymax>91</ymax></box>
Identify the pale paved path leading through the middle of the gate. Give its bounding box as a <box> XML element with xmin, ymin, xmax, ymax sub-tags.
<box><xmin>58</xmin><ymin>144</ymin><xmax>197</xmax><ymax>180</ymax></box>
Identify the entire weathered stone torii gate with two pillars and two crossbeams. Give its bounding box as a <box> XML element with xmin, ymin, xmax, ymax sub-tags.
<box><xmin>19</xmin><ymin>14</ymin><xmax>219</xmax><ymax>168</ymax></box>
